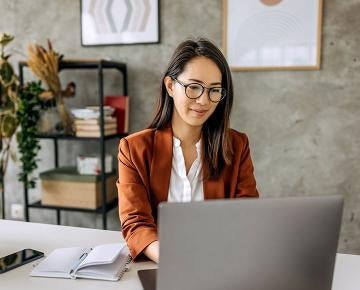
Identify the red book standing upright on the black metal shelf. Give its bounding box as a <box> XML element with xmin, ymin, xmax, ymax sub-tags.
<box><xmin>104</xmin><ymin>96</ymin><xmax>129</xmax><ymax>133</ymax></box>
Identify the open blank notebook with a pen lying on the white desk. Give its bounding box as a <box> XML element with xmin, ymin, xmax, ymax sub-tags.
<box><xmin>30</xmin><ymin>243</ymin><xmax>131</xmax><ymax>281</ymax></box>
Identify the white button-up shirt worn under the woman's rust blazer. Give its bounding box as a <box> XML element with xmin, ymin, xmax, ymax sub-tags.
<box><xmin>168</xmin><ymin>137</ymin><xmax>204</xmax><ymax>202</ymax></box>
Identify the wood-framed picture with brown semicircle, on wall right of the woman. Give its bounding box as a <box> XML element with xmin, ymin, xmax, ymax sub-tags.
<box><xmin>223</xmin><ymin>0</ymin><xmax>323</xmax><ymax>71</ymax></box>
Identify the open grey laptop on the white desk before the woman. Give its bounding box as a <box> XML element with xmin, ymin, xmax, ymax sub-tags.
<box><xmin>138</xmin><ymin>196</ymin><xmax>343</xmax><ymax>290</ymax></box>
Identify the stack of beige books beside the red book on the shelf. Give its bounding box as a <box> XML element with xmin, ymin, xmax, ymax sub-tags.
<box><xmin>75</xmin><ymin>117</ymin><xmax>117</xmax><ymax>137</ymax></box>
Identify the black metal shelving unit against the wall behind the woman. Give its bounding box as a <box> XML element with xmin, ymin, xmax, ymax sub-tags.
<box><xmin>19</xmin><ymin>59</ymin><xmax>128</xmax><ymax>229</ymax></box>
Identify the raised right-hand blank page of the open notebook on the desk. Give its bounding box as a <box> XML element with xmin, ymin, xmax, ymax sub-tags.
<box><xmin>78</xmin><ymin>243</ymin><xmax>126</xmax><ymax>269</ymax></box>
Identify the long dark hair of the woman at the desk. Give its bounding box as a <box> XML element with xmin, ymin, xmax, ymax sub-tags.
<box><xmin>148</xmin><ymin>38</ymin><xmax>233</xmax><ymax>179</ymax></box>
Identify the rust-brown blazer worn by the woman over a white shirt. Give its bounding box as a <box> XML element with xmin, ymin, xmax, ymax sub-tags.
<box><xmin>117</xmin><ymin>126</ymin><xmax>259</xmax><ymax>259</ymax></box>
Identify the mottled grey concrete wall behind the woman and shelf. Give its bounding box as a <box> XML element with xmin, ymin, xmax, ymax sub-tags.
<box><xmin>0</xmin><ymin>0</ymin><xmax>360</xmax><ymax>254</ymax></box>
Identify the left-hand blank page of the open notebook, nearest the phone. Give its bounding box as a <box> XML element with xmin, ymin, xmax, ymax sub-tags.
<box><xmin>32</xmin><ymin>247</ymin><xmax>87</xmax><ymax>274</ymax></box>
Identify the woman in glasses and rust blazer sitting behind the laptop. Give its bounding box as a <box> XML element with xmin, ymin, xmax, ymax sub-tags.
<box><xmin>117</xmin><ymin>39</ymin><xmax>258</xmax><ymax>262</ymax></box>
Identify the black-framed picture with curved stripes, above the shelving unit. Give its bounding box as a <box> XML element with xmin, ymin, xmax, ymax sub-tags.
<box><xmin>80</xmin><ymin>0</ymin><xmax>159</xmax><ymax>46</ymax></box>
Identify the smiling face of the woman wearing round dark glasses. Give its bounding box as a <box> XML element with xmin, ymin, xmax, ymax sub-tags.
<box><xmin>164</xmin><ymin>56</ymin><xmax>222</xmax><ymax>127</ymax></box>
